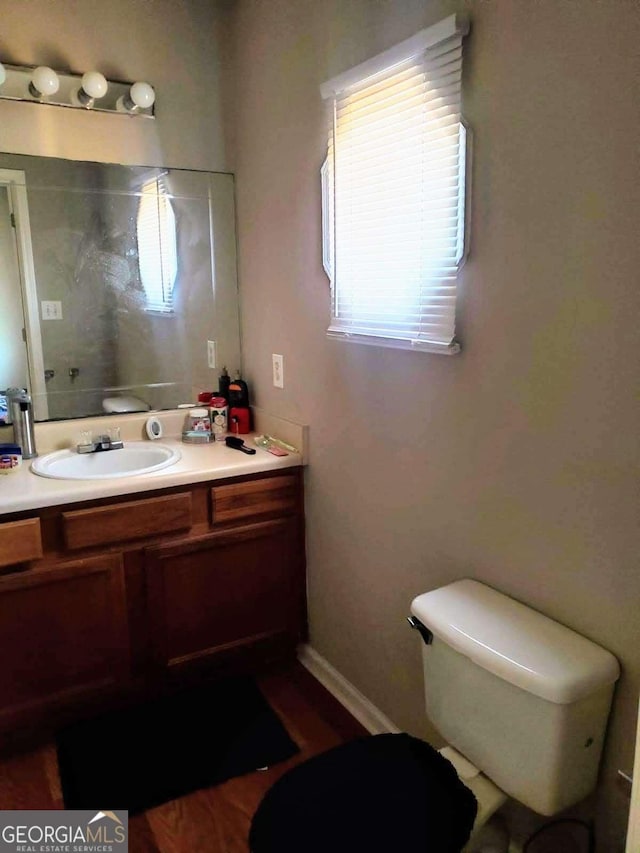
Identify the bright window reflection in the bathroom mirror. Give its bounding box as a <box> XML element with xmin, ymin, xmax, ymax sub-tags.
<box><xmin>137</xmin><ymin>178</ymin><xmax>178</xmax><ymax>314</ymax></box>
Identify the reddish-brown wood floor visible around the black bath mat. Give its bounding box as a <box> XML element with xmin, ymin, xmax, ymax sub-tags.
<box><xmin>0</xmin><ymin>665</ymin><xmax>366</xmax><ymax>853</ymax></box>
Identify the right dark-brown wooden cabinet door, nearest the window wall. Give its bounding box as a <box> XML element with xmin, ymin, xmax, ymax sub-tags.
<box><xmin>146</xmin><ymin>518</ymin><xmax>304</xmax><ymax>671</ymax></box>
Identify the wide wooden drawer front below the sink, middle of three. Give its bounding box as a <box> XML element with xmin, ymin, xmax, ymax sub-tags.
<box><xmin>62</xmin><ymin>492</ymin><xmax>193</xmax><ymax>550</ymax></box>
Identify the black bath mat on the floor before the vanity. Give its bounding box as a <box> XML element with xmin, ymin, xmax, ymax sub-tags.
<box><xmin>57</xmin><ymin>678</ymin><xmax>298</xmax><ymax>814</ymax></box>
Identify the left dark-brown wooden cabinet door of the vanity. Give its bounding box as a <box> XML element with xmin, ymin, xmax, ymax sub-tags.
<box><xmin>0</xmin><ymin>555</ymin><xmax>128</xmax><ymax>728</ymax></box>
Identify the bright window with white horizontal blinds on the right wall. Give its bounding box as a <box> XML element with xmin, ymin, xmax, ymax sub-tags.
<box><xmin>321</xmin><ymin>15</ymin><xmax>467</xmax><ymax>353</ymax></box>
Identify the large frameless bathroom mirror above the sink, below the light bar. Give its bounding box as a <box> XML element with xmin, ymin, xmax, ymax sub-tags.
<box><xmin>0</xmin><ymin>154</ymin><xmax>240</xmax><ymax>421</ymax></box>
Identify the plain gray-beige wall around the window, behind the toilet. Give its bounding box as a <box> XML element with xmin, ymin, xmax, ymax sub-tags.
<box><xmin>224</xmin><ymin>0</ymin><xmax>640</xmax><ymax>853</ymax></box>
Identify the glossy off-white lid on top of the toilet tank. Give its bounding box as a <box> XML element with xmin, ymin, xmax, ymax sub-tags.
<box><xmin>411</xmin><ymin>579</ymin><xmax>620</xmax><ymax>704</ymax></box>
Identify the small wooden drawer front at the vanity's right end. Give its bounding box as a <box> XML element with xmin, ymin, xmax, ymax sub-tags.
<box><xmin>211</xmin><ymin>476</ymin><xmax>298</xmax><ymax>524</ymax></box>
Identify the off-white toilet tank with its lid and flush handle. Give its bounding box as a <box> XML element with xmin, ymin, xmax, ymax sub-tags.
<box><xmin>411</xmin><ymin>580</ymin><xmax>620</xmax><ymax>815</ymax></box>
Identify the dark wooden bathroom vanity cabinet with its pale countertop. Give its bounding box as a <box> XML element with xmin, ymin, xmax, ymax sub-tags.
<box><xmin>0</xmin><ymin>446</ymin><xmax>306</xmax><ymax>747</ymax></box>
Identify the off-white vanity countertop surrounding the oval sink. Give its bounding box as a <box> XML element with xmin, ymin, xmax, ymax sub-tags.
<box><xmin>0</xmin><ymin>434</ymin><xmax>303</xmax><ymax>516</ymax></box>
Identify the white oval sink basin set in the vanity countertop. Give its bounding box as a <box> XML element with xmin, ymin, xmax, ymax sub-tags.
<box><xmin>31</xmin><ymin>441</ymin><xmax>182</xmax><ymax>480</ymax></box>
